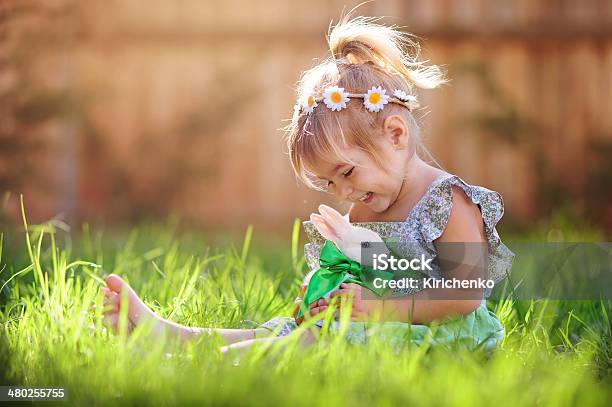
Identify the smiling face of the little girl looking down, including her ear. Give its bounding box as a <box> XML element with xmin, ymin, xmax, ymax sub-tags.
<box><xmin>311</xmin><ymin>115</ymin><xmax>410</xmax><ymax>213</ymax></box>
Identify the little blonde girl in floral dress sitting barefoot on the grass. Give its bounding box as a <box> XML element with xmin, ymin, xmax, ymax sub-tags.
<box><xmin>103</xmin><ymin>16</ymin><xmax>513</xmax><ymax>350</ymax></box>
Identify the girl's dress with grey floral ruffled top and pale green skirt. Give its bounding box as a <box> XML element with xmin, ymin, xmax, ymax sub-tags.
<box><xmin>260</xmin><ymin>174</ymin><xmax>514</xmax><ymax>349</ymax></box>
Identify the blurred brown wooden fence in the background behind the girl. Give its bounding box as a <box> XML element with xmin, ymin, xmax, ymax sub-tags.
<box><xmin>0</xmin><ymin>0</ymin><xmax>612</xmax><ymax>228</ymax></box>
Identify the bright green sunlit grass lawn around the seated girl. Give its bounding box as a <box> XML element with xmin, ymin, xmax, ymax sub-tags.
<box><xmin>0</xmin><ymin>209</ymin><xmax>612</xmax><ymax>406</ymax></box>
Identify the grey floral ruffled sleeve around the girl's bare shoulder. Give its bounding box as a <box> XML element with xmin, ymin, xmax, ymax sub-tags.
<box><xmin>409</xmin><ymin>175</ymin><xmax>514</xmax><ymax>283</ymax></box>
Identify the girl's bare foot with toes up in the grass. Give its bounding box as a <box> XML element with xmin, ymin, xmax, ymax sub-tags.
<box><xmin>102</xmin><ymin>274</ymin><xmax>160</xmax><ymax>332</ymax></box>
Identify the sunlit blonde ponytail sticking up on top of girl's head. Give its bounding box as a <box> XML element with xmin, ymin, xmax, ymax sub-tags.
<box><xmin>328</xmin><ymin>15</ymin><xmax>446</xmax><ymax>89</ymax></box>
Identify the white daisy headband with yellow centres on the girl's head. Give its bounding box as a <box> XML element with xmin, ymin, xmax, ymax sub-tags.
<box><xmin>295</xmin><ymin>86</ymin><xmax>419</xmax><ymax>113</ymax></box>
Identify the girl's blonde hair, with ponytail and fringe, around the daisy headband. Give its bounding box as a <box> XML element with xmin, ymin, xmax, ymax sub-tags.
<box><xmin>285</xmin><ymin>15</ymin><xmax>446</xmax><ymax>189</ymax></box>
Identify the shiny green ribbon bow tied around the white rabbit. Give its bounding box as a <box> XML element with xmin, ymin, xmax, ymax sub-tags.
<box><xmin>297</xmin><ymin>240</ymin><xmax>393</xmax><ymax>318</ymax></box>
